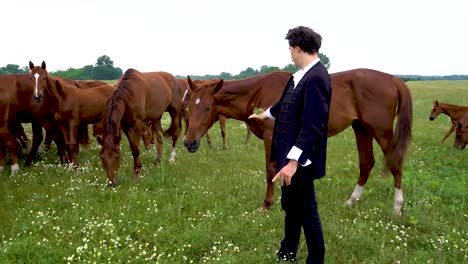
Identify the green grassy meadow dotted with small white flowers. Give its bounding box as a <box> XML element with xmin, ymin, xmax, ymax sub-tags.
<box><xmin>0</xmin><ymin>81</ymin><xmax>468</xmax><ymax>264</ymax></box>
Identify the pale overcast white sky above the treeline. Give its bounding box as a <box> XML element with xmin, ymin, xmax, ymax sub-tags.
<box><xmin>0</xmin><ymin>0</ymin><xmax>468</xmax><ymax>75</ymax></box>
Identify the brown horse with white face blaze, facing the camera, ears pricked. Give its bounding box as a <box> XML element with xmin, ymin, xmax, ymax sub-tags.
<box><xmin>29</xmin><ymin>62</ymin><xmax>114</xmax><ymax>168</ymax></box>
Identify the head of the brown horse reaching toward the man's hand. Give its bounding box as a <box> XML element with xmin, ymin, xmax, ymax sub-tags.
<box><xmin>184</xmin><ymin>76</ymin><xmax>224</xmax><ymax>152</ymax></box>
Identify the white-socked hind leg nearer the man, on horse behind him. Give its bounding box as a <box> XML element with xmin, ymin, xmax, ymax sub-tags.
<box><xmin>346</xmin><ymin>122</ymin><xmax>375</xmax><ymax>206</ymax></box>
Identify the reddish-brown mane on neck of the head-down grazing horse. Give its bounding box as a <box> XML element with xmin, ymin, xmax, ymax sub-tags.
<box><xmin>103</xmin><ymin>69</ymin><xmax>139</xmax><ymax>151</ymax></box>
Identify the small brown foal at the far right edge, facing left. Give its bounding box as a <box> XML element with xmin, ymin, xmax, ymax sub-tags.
<box><xmin>429</xmin><ymin>100</ymin><xmax>468</xmax><ymax>144</ymax></box>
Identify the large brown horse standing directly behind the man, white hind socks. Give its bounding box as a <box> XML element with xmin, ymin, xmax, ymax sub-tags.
<box><xmin>184</xmin><ymin>69</ymin><xmax>412</xmax><ymax>214</ymax></box>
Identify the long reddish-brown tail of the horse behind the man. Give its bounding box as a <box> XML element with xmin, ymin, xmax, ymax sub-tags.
<box><xmin>385</xmin><ymin>77</ymin><xmax>413</xmax><ymax>170</ymax></box>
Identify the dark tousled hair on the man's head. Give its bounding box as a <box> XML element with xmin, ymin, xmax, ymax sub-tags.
<box><xmin>285</xmin><ymin>26</ymin><xmax>322</xmax><ymax>54</ymax></box>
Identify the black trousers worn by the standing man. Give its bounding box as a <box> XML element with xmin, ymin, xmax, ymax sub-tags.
<box><xmin>278</xmin><ymin>167</ymin><xmax>325</xmax><ymax>264</ymax></box>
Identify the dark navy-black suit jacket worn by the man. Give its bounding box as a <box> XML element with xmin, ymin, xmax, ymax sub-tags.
<box><xmin>270</xmin><ymin>62</ymin><xmax>332</xmax><ymax>179</ymax></box>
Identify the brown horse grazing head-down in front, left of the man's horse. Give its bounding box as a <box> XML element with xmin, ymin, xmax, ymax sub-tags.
<box><xmin>101</xmin><ymin>69</ymin><xmax>182</xmax><ymax>187</ymax></box>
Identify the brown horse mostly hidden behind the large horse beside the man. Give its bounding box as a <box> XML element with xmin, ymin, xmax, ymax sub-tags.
<box><xmin>177</xmin><ymin>79</ymin><xmax>252</xmax><ymax>149</ymax></box>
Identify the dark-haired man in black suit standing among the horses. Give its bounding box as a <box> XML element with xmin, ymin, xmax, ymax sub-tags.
<box><xmin>249</xmin><ymin>26</ymin><xmax>331</xmax><ymax>263</ymax></box>
